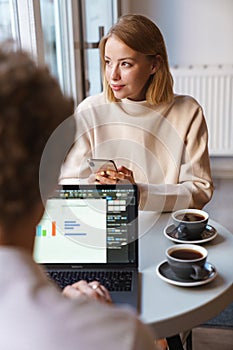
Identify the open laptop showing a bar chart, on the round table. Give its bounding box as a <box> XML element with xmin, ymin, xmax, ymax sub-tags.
<box><xmin>34</xmin><ymin>184</ymin><xmax>138</xmax><ymax>309</ymax></box>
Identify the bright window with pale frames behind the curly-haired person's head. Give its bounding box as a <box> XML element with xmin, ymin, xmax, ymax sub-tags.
<box><xmin>0</xmin><ymin>0</ymin><xmax>119</xmax><ymax>103</ymax></box>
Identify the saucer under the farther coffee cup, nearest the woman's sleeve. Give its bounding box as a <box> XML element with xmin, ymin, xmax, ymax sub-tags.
<box><xmin>164</xmin><ymin>224</ymin><xmax>218</xmax><ymax>244</ymax></box>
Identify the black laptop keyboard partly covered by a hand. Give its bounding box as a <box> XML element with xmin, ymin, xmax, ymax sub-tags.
<box><xmin>47</xmin><ymin>270</ymin><xmax>132</xmax><ymax>292</ymax></box>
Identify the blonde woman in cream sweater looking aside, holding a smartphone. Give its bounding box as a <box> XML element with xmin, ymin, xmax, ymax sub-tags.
<box><xmin>60</xmin><ymin>15</ymin><xmax>213</xmax><ymax>212</ymax></box>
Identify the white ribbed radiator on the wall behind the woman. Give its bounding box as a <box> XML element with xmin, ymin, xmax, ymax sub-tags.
<box><xmin>171</xmin><ymin>65</ymin><xmax>233</xmax><ymax>156</ymax></box>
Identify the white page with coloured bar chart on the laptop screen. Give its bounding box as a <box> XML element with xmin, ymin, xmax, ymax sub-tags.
<box><xmin>34</xmin><ymin>199</ymin><xmax>107</xmax><ymax>263</ymax></box>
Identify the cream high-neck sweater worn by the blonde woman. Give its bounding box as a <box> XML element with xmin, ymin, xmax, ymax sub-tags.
<box><xmin>60</xmin><ymin>93</ymin><xmax>213</xmax><ymax>212</ymax></box>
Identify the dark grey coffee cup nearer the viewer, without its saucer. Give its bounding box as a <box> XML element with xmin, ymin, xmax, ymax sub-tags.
<box><xmin>166</xmin><ymin>244</ymin><xmax>208</xmax><ymax>280</ymax></box>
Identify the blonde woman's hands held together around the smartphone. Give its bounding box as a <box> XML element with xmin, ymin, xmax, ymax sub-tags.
<box><xmin>96</xmin><ymin>166</ymin><xmax>135</xmax><ymax>185</ymax></box>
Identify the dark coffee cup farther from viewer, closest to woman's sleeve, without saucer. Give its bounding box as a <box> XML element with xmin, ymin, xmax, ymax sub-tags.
<box><xmin>172</xmin><ymin>209</ymin><xmax>209</xmax><ymax>240</ymax></box>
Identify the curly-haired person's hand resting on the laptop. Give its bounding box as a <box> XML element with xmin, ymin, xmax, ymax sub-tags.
<box><xmin>62</xmin><ymin>280</ymin><xmax>112</xmax><ymax>303</ymax></box>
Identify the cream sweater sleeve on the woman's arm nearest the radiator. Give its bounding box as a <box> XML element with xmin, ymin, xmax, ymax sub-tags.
<box><xmin>138</xmin><ymin>106</ymin><xmax>213</xmax><ymax>212</ymax></box>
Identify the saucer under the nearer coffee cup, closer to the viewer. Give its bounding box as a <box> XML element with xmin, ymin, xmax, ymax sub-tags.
<box><xmin>156</xmin><ymin>260</ymin><xmax>217</xmax><ymax>287</ymax></box>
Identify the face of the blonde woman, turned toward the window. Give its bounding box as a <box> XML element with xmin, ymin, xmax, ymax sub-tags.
<box><xmin>105</xmin><ymin>36</ymin><xmax>157</xmax><ymax>101</ymax></box>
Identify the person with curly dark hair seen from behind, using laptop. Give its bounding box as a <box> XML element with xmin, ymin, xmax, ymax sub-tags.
<box><xmin>0</xmin><ymin>44</ymin><xmax>155</xmax><ymax>350</ymax></box>
